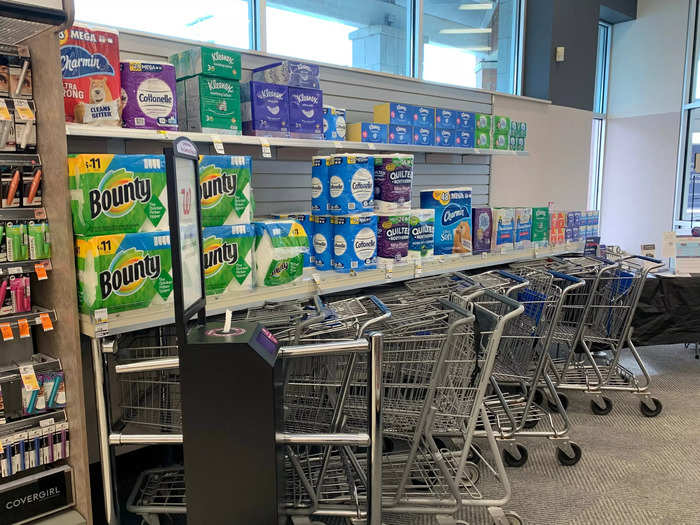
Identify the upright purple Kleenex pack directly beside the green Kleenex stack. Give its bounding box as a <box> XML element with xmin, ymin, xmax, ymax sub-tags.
<box><xmin>241</xmin><ymin>82</ymin><xmax>289</xmax><ymax>137</ymax></box>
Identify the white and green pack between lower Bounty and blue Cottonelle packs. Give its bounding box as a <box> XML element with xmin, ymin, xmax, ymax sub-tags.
<box><xmin>253</xmin><ymin>219</ymin><xmax>309</xmax><ymax>286</ymax></box>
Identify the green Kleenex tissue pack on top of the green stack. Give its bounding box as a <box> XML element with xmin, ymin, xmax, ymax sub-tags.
<box><xmin>168</xmin><ymin>47</ymin><xmax>241</xmax><ymax>80</ymax></box>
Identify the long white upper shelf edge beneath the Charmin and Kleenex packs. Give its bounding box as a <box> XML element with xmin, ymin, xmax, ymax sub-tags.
<box><xmin>66</xmin><ymin>124</ymin><xmax>528</xmax><ymax>157</ymax></box>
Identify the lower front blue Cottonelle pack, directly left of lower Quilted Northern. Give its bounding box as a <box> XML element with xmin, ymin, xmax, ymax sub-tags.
<box><xmin>331</xmin><ymin>214</ymin><xmax>377</xmax><ymax>273</ymax></box>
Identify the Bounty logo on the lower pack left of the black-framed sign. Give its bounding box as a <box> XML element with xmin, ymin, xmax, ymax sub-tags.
<box><xmin>98</xmin><ymin>248</ymin><xmax>160</xmax><ymax>299</ymax></box>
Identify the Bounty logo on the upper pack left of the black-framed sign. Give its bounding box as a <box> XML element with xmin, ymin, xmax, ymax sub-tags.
<box><xmin>88</xmin><ymin>168</ymin><xmax>152</xmax><ymax>219</ymax></box>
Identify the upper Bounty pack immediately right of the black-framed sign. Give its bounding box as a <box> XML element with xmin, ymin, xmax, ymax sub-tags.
<box><xmin>199</xmin><ymin>155</ymin><xmax>254</xmax><ymax>226</ymax></box>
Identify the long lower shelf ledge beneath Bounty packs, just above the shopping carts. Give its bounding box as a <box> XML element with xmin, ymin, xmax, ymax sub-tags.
<box><xmin>80</xmin><ymin>243</ymin><xmax>583</xmax><ymax>337</ymax></box>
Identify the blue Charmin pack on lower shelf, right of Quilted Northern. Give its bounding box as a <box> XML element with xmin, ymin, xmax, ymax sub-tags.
<box><xmin>420</xmin><ymin>187</ymin><xmax>472</xmax><ymax>255</ymax></box>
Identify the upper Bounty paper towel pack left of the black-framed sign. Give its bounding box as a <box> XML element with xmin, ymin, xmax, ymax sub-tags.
<box><xmin>68</xmin><ymin>154</ymin><xmax>168</xmax><ymax>235</ymax></box>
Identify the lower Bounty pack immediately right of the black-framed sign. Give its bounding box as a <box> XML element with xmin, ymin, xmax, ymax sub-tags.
<box><xmin>202</xmin><ymin>224</ymin><xmax>255</xmax><ymax>295</ymax></box>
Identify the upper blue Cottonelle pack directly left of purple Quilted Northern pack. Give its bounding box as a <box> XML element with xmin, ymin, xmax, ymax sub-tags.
<box><xmin>328</xmin><ymin>153</ymin><xmax>374</xmax><ymax>215</ymax></box>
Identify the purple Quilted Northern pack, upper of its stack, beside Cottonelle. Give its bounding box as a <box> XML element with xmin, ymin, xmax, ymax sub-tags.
<box><xmin>374</xmin><ymin>153</ymin><xmax>413</xmax><ymax>213</ymax></box>
